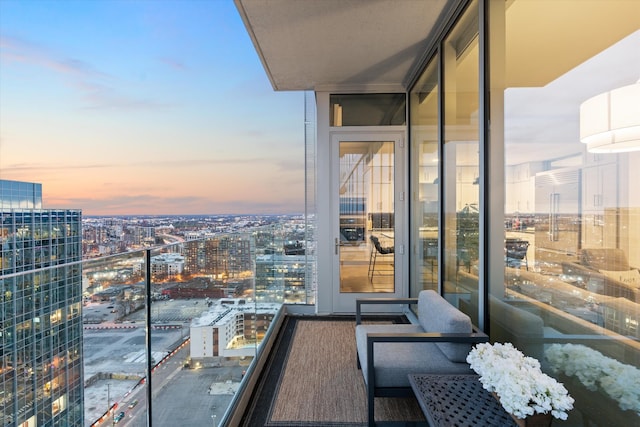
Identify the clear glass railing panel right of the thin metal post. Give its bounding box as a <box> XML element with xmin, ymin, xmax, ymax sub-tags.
<box><xmin>148</xmin><ymin>237</ymin><xmax>260</xmax><ymax>425</ymax></box>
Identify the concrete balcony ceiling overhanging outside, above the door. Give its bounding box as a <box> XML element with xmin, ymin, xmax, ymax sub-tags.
<box><xmin>235</xmin><ymin>0</ymin><xmax>457</xmax><ymax>92</ymax></box>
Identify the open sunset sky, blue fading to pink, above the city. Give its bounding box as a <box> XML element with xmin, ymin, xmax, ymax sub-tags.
<box><xmin>0</xmin><ymin>0</ymin><xmax>304</xmax><ymax>215</ymax></box>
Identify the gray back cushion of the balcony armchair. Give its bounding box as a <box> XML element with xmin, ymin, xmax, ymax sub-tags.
<box><xmin>418</xmin><ymin>290</ymin><xmax>473</xmax><ymax>363</ymax></box>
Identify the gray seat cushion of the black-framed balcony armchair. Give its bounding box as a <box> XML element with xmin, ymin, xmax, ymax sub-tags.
<box><xmin>356</xmin><ymin>325</ymin><xmax>473</xmax><ymax>387</ymax></box>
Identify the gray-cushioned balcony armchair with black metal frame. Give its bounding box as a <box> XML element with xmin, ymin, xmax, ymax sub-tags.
<box><xmin>356</xmin><ymin>290</ymin><xmax>489</xmax><ymax>426</ymax></box>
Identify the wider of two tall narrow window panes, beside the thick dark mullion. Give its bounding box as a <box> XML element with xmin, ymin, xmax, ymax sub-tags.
<box><xmin>442</xmin><ymin>2</ymin><xmax>480</xmax><ymax>324</ymax></box>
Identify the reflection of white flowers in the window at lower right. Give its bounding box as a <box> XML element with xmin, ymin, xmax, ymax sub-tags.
<box><xmin>545</xmin><ymin>344</ymin><xmax>640</xmax><ymax>414</ymax></box>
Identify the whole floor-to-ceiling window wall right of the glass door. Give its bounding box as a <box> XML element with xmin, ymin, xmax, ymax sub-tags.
<box><xmin>410</xmin><ymin>0</ymin><xmax>640</xmax><ymax>426</ymax></box>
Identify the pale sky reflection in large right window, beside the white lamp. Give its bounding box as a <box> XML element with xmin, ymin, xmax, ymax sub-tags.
<box><xmin>505</xmin><ymin>30</ymin><xmax>640</xmax><ymax>164</ymax></box>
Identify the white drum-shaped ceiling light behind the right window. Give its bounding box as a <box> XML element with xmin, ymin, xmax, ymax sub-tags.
<box><xmin>580</xmin><ymin>81</ymin><xmax>640</xmax><ymax>153</ymax></box>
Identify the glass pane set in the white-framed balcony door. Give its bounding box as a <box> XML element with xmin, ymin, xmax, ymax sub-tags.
<box><xmin>336</xmin><ymin>142</ymin><xmax>395</xmax><ymax>292</ymax></box>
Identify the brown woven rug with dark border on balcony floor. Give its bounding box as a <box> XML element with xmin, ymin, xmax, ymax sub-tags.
<box><xmin>244</xmin><ymin>317</ymin><xmax>424</xmax><ymax>427</ymax></box>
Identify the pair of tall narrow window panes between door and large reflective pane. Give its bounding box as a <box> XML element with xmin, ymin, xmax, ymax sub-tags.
<box><xmin>409</xmin><ymin>1</ymin><xmax>481</xmax><ymax>324</ymax></box>
